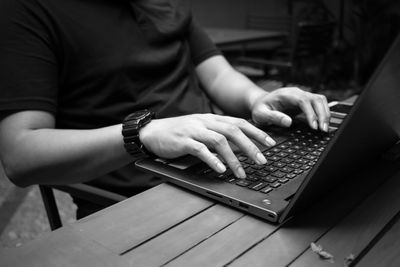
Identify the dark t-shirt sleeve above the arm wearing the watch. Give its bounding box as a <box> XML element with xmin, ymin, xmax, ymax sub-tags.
<box><xmin>0</xmin><ymin>0</ymin><xmax>58</xmax><ymax>114</ymax></box>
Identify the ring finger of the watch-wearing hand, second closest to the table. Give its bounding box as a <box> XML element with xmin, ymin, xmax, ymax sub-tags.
<box><xmin>195</xmin><ymin>130</ymin><xmax>246</xmax><ymax>178</ymax></box>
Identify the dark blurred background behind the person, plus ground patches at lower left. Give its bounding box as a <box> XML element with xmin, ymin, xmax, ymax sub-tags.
<box><xmin>0</xmin><ymin>0</ymin><xmax>400</xmax><ymax>250</ymax></box>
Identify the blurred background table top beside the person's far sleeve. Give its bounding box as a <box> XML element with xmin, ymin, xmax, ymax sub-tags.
<box><xmin>205</xmin><ymin>28</ymin><xmax>288</xmax><ymax>47</ymax></box>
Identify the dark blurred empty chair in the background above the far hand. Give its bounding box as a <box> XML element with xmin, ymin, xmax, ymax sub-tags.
<box><xmin>236</xmin><ymin>21</ymin><xmax>336</xmax><ymax>90</ymax></box>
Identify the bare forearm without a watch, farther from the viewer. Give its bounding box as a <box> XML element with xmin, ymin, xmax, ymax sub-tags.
<box><xmin>198</xmin><ymin>57</ymin><xmax>266</xmax><ymax>118</ymax></box>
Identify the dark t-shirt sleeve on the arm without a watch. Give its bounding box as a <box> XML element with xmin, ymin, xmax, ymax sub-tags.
<box><xmin>189</xmin><ymin>20</ymin><xmax>221</xmax><ymax>66</ymax></box>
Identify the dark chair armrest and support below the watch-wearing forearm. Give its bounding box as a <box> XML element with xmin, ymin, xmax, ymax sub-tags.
<box><xmin>39</xmin><ymin>184</ymin><xmax>127</xmax><ymax>231</ymax></box>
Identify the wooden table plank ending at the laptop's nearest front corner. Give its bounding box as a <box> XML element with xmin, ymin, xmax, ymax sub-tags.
<box><xmin>166</xmin><ymin>216</ymin><xmax>278</xmax><ymax>267</ymax></box>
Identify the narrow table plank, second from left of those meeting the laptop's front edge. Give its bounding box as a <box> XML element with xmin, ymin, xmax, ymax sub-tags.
<box><xmin>123</xmin><ymin>205</ymin><xmax>243</xmax><ymax>266</ymax></box>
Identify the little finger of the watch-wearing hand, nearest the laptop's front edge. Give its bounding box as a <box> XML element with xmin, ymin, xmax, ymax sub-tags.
<box><xmin>186</xmin><ymin>139</ymin><xmax>226</xmax><ymax>173</ymax></box>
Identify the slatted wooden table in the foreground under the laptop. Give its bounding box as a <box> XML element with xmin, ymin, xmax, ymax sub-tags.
<box><xmin>0</xmin><ymin>155</ymin><xmax>400</xmax><ymax>267</ymax></box>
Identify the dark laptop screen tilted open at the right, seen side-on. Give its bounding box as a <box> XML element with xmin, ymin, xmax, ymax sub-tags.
<box><xmin>283</xmin><ymin>33</ymin><xmax>400</xmax><ymax>222</ymax></box>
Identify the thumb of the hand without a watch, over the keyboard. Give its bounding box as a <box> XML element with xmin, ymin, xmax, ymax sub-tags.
<box><xmin>253</xmin><ymin>105</ymin><xmax>292</xmax><ymax>127</ymax></box>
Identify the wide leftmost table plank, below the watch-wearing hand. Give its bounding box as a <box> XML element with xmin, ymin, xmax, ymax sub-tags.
<box><xmin>72</xmin><ymin>184</ymin><xmax>214</xmax><ymax>254</ymax></box>
